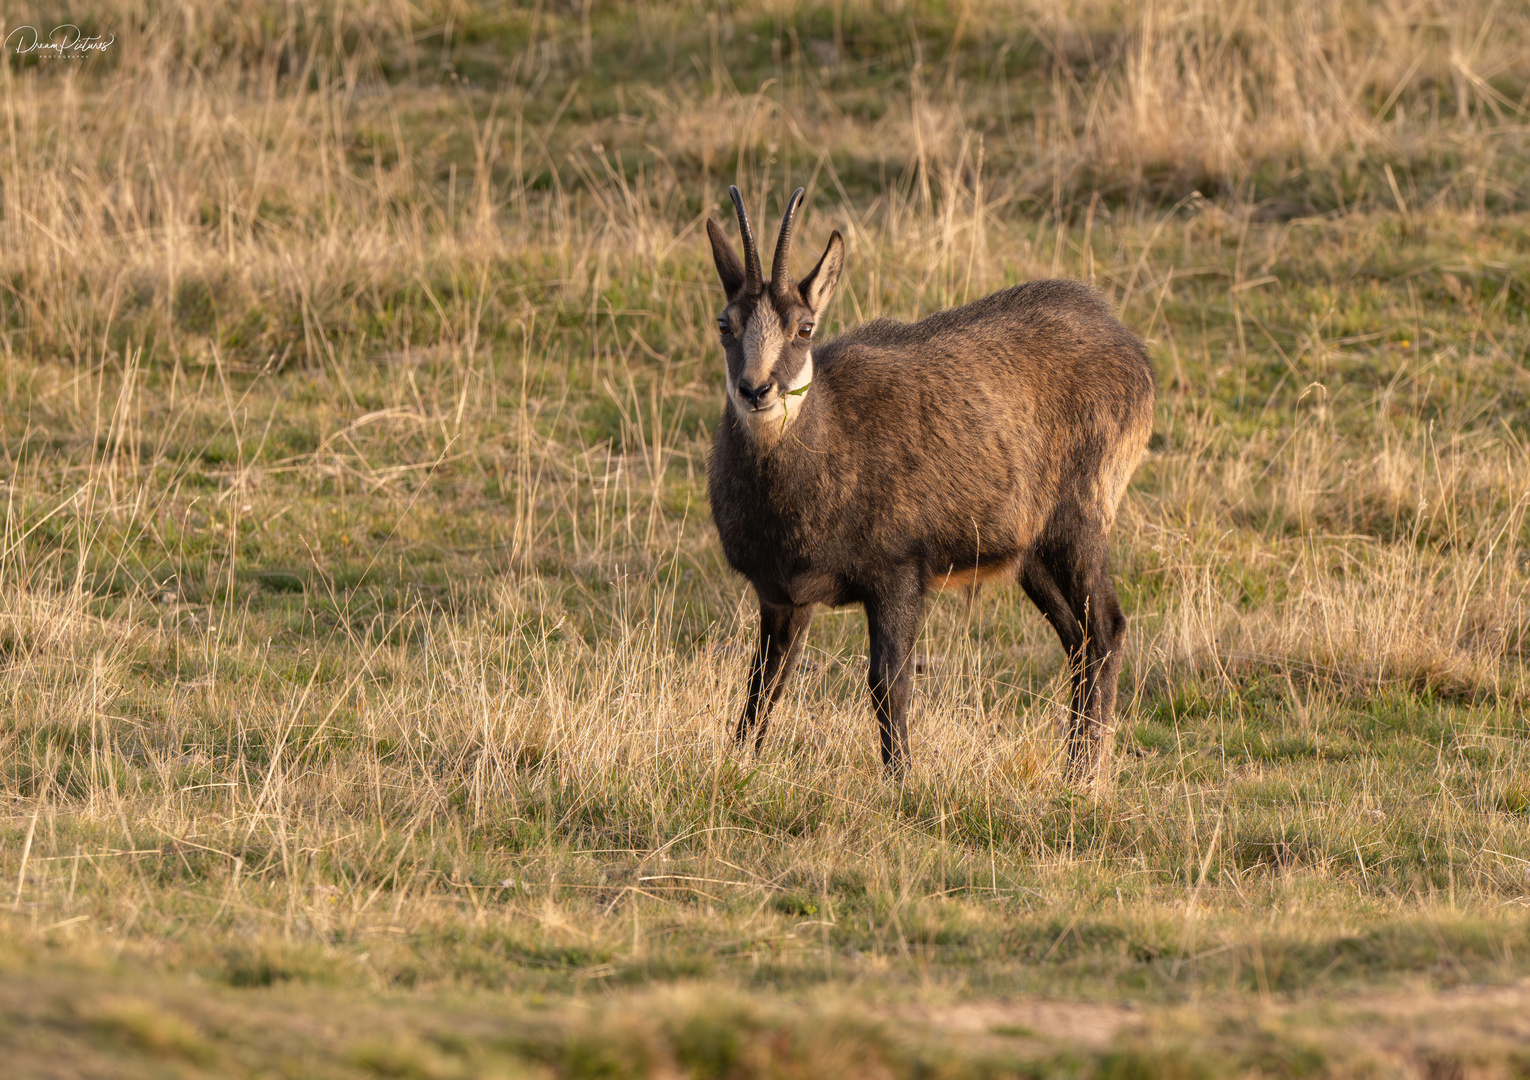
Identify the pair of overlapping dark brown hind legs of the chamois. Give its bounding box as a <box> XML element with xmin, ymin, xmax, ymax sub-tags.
<box><xmin>1021</xmin><ymin>537</ymin><xmax>1126</xmax><ymax>786</ymax></box>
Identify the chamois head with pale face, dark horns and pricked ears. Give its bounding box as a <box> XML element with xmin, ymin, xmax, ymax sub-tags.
<box><xmin>707</xmin><ymin>187</ymin><xmax>845</xmax><ymax>444</ymax></box>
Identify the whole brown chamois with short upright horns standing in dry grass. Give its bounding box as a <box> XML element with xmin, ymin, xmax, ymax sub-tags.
<box><xmin>707</xmin><ymin>188</ymin><xmax>1155</xmax><ymax>785</ymax></box>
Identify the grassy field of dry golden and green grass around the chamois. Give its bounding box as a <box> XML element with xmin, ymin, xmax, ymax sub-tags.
<box><xmin>0</xmin><ymin>0</ymin><xmax>1530</xmax><ymax>1080</ymax></box>
